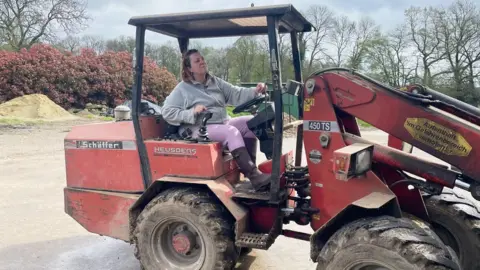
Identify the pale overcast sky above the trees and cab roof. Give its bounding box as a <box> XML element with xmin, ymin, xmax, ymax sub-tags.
<box><xmin>81</xmin><ymin>0</ymin><xmax>458</xmax><ymax>46</ymax></box>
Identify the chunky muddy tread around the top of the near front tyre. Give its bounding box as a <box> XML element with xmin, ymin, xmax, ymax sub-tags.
<box><xmin>317</xmin><ymin>216</ymin><xmax>460</xmax><ymax>270</ymax></box>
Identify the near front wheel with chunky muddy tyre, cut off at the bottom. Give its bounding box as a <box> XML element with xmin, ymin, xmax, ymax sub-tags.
<box><xmin>317</xmin><ymin>216</ymin><xmax>460</xmax><ymax>270</ymax></box>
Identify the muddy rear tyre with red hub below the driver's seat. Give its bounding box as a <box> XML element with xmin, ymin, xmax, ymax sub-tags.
<box><xmin>134</xmin><ymin>188</ymin><xmax>238</xmax><ymax>270</ymax></box>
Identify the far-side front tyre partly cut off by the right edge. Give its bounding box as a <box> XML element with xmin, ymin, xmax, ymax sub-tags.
<box><xmin>424</xmin><ymin>189</ymin><xmax>480</xmax><ymax>270</ymax></box>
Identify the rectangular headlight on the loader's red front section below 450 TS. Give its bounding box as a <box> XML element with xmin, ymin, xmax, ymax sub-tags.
<box><xmin>333</xmin><ymin>143</ymin><xmax>373</xmax><ymax>181</ymax></box>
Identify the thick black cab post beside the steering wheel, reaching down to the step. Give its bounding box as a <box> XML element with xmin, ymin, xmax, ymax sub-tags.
<box><xmin>267</xmin><ymin>16</ymin><xmax>283</xmax><ymax>203</ymax></box>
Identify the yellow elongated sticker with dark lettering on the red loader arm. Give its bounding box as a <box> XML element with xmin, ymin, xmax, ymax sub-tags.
<box><xmin>403</xmin><ymin>118</ymin><xmax>472</xmax><ymax>157</ymax></box>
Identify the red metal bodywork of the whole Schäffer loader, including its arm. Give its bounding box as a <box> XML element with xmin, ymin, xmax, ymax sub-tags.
<box><xmin>65</xmin><ymin>71</ymin><xmax>480</xmax><ymax>255</ymax></box>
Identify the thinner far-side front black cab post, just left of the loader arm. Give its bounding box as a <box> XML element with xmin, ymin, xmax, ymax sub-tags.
<box><xmin>290</xmin><ymin>32</ymin><xmax>304</xmax><ymax>166</ymax></box>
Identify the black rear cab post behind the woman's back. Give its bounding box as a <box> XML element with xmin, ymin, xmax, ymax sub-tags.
<box><xmin>132</xmin><ymin>25</ymin><xmax>151</xmax><ymax>189</ymax></box>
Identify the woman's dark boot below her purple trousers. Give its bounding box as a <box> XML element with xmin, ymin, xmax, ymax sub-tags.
<box><xmin>231</xmin><ymin>147</ymin><xmax>270</xmax><ymax>191</ymax></box>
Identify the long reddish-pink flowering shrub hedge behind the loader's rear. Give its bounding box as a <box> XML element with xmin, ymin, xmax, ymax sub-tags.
<box><xmin>0</xmin><ymin>44</ymin><xmax>177</xmax><ymax>109</ymax></box>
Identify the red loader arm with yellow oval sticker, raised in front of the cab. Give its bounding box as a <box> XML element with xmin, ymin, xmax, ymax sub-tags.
<box><xmin>306</xmin><ymin>68</ymin><xmax>480</xmax><ymax>196</ymax></box>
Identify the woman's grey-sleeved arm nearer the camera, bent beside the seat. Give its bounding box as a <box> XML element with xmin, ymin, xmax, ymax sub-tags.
<box><xmin>162</xmin><ymin>88</ymin><xmax>195</xmax><ymax>126</ymax></box>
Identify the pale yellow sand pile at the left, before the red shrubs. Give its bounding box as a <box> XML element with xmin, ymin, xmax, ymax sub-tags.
<box><xmin>0</xmin><ymin>94</ymin><xmax>75</xmax><ymax>121</ymax></box>
